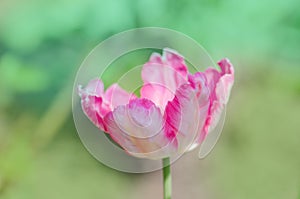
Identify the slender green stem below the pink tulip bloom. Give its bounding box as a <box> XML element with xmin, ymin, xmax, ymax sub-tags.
<box><xmin>163</xmin><ymin>158</ymin><xmax>172</xmax><ymax>199</ymax></box>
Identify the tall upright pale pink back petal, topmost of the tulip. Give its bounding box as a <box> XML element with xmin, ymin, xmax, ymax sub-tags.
<box><xmin>141</xmin><ymin>49</ymin><xmax>187</xmax><ymax>111</ymax></box>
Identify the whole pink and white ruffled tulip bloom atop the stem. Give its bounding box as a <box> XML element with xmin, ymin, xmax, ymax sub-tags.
<box><xmin>79</xmin><ymin>49</ymin><xmax>234</xmax><ymax>159</ymax></box>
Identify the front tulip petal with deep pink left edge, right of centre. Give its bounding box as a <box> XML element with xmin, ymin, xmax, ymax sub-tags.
<box><xmin>165</xmin><ymin>84</ymin><xmax>208</xmax><ymax>152</ymax></box>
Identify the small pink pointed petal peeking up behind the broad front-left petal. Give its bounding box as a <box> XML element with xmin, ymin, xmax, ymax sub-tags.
<box><xmin>103</xmin><ymin>83</ymin><xmax>135</xmax><ymax>110</ymax></box>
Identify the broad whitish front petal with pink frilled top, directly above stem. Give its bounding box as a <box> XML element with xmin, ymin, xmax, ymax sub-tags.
<box><xmin>104</xmin><ymin>99</ymin><xmax>174</xmax><ymax>159</ymax></box>
